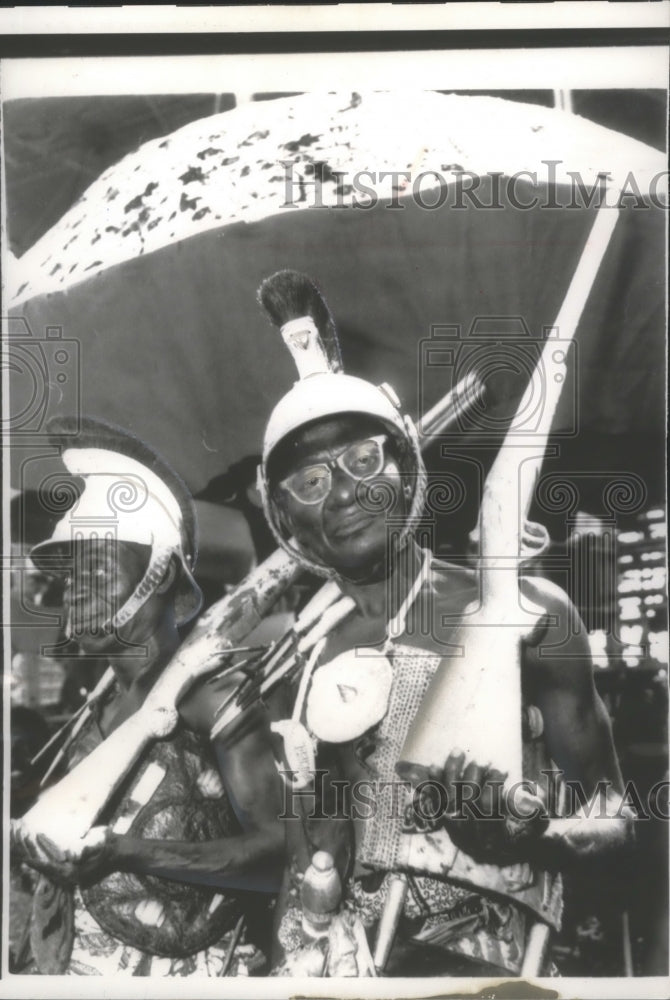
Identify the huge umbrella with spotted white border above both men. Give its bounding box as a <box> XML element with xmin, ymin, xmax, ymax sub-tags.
<box><xmin>7</xmin><ymin>92</ymin><xmax>665</xmax><ymax>516</ymax></box>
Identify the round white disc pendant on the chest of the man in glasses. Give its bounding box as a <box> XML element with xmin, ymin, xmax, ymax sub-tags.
<box><xmin>306</xmin><ymin>649</ymin><xmax>393</xmax><ymax>743</ymax></box>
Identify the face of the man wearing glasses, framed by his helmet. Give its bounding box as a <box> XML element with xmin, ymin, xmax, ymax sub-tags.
<box><xmin>273</xmin><ymin>417</ymin><xmax>406</xmax><ymax>580</ymax></box>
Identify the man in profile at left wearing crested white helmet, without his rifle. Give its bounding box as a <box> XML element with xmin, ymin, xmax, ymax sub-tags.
<box><xmin>13</xmin><ymin>420</ymin><xmax>283</xmax><ymax>975</ymax></box>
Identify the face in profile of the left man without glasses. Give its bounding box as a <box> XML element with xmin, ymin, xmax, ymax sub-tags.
<box><xmin>63</xmin><ymin>540</ymin><xmax>149</xmax><ymax>652</ymax></box>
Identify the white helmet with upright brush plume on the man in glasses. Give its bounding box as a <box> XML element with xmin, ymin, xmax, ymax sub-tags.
<box><xmin>258</xmin><ymin>271</ymin><xmax>426</xmax><ymax>576</ymax></box>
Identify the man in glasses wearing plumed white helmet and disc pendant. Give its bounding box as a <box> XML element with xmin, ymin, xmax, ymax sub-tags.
<box><xmin>260</xmin><ymin>272</ymin><xmax>631</xmax><ymax>976</ymax></box>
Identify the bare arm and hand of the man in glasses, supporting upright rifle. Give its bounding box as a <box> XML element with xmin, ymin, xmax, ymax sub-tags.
<box><xmin>436</xmin><ymin>578</ymin><xmax>634</xmax><ymax>868</ymax></box>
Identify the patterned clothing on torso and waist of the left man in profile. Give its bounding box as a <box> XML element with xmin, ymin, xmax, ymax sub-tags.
<box><xmin>31</xmin><ymin>688</ymin><xmax>263</xmax><ymax>976</ymax></box>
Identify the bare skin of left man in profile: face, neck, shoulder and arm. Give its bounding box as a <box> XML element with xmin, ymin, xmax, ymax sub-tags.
<box><xmin>16</xmin><ymin>542</ymin><xmax>284</xmax><ymax>891</ymax></box>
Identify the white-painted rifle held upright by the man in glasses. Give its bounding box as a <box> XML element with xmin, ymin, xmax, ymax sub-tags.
<box><xmin>374</xmin><ymin>207</ymin><xmax>619</xmax><ymax>975</ymax></box>
